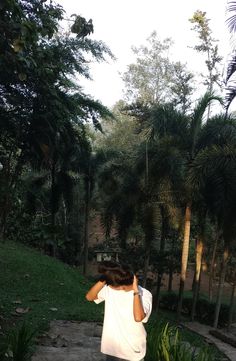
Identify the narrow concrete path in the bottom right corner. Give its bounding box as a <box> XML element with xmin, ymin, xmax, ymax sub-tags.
<box><xmin>182</xmin><ymin>322</ymin><xmax>236</xmax><ymax>361</ymax></box>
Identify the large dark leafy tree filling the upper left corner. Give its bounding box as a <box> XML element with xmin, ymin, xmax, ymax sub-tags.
<box><xmin>0</xmin><ymin>0</ymin><xmax>112</xmax><ymax>239</ymax></box>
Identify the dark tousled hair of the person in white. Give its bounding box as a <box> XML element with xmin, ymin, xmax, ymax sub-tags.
<box><xmin>98</xmin><ymin>261</ymin><xmax>134</xmax><ymax>286</ymax></box>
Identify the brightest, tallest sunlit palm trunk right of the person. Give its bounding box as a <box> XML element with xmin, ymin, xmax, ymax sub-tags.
<box><xmin>177</xmin><ymin>204</ymin><xmax>191</xmax><ymax>322</ymax></box>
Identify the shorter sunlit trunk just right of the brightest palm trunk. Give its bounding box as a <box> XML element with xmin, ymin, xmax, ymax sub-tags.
<box><xmin>191</xmin><ymin>237</ymin><xmax>203</xmax><ymax>321</ymax></box>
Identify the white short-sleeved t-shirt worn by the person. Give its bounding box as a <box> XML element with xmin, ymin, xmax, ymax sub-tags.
<box><xmin>94</xmin><ymin>285</ymin><xmax>152</xmax><ymax>361</ymax></box>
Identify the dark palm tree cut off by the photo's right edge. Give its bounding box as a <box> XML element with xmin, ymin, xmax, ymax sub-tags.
<box><xmin>189</xmin><ymin>115</ymin><xmax>236</xmax><ymax>327</ymax></box>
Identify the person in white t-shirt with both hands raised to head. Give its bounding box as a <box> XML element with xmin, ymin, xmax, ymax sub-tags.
<box><xmin>86</xmin><ymin>261</ymin><xmax>152</xmax><ymax>361</ymax></box>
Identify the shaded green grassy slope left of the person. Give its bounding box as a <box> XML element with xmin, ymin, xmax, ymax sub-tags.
<box><xmin>0</xmin><ymin>242</ymin><xmax>102</xmax><ymax>329</ymax></box>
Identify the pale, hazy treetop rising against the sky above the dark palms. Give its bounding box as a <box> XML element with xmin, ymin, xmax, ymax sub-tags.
<box><xmin>122</xmin><ymin>32</ymin><xmax>193</xmax><ymax>109</ymax></box>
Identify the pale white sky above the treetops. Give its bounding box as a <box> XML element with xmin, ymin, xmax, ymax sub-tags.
<box><xmin>57</xmin><ymin>0</ymin><xmax>232</xmax><ymax>107</ymax></box>
